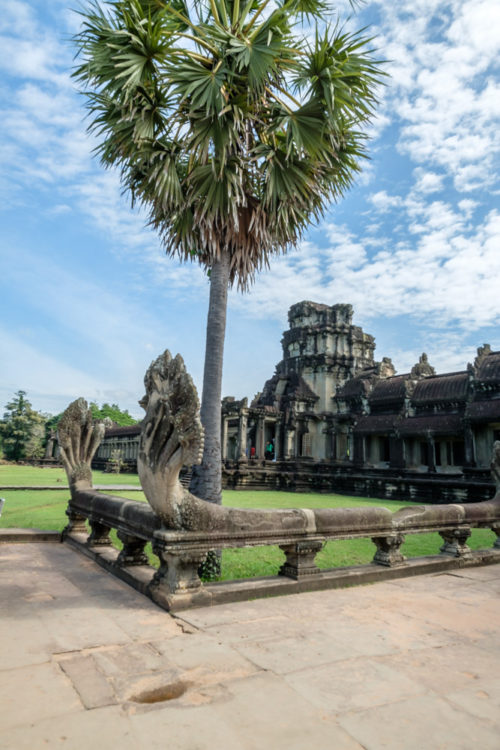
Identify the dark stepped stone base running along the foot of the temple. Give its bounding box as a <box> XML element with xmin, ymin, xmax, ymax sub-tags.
<box><xmin>222</xmin><ymin>460</ymin><xmax>495</xmax><ymax>504</ymax></box>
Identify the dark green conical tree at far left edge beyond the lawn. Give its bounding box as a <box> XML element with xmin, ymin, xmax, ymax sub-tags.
<box><xmin>0</xmin><ymin>391</ymin><xmax>47</xmax><ymax>461</ymax></box>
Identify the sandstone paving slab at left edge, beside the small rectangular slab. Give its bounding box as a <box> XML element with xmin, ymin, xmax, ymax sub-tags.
<box><xmin>0</xmin><ymin>663</ymin><xmax>82</xmax><ymax>736</ymax></box>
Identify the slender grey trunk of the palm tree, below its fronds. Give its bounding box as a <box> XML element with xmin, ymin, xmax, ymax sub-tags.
<box><xmin>190</xmin><ymin>252</ymin><xmax>230</xmax><ymax>505</ymax></box>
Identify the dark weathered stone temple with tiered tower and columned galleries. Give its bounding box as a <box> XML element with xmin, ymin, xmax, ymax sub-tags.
<box><xmin>96</xmin><ymin>302</ymin><xmax>500</xmax><ymax>502</ymax></box>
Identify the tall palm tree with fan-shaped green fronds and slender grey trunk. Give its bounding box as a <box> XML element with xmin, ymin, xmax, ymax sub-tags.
<box><xmin>75</xmin><ymin>0</ymin><xmax>382</xmax><ymax>516</ymax></box>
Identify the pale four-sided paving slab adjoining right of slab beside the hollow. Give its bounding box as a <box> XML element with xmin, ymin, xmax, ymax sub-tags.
<box><xmin>285</xmin><ymin>658</ymin><xmax>429</xmax><ymax>714</ymax></box>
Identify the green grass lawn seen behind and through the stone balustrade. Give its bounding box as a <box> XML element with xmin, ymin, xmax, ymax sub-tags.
<box><xmin>0</xmin><ymin>466</ymin><xmax>496</xmax><ymax>580</ymax></box>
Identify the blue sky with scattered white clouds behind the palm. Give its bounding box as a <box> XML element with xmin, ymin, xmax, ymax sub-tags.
<box><xmin>0</xmin><ymin>0</ymin><xmax>500</xmax><ymax>418</ymax></box>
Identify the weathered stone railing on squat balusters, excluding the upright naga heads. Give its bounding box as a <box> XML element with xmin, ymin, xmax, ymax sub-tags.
<box><xmin>65</xmin><ymin>484</ymin><xmax>500</xmax><ymax>610</ymax></box>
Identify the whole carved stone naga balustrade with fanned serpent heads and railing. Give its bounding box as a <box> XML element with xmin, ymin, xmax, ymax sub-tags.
<box><xmin>58</xmin><ymin>351</ymin><xmax>500</xmax><ymax>610</ymax></box>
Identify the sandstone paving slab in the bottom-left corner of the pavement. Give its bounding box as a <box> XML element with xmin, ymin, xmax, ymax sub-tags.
<box><xmin>0</xmin><ymin>706</ymin><xmax>138</xmax><ymax>750</ymax></box>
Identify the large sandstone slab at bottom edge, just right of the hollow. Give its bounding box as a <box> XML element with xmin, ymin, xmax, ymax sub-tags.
<box><xmin>130</xmin><ymin>674</ymin><xmax>362</xmax><ymax>750</ymax></box>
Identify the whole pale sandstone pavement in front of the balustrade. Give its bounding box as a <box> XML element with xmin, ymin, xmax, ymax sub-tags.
<box><xmin>0</xmin><ymin>544</ymin><xmax>500</xmax><ymax>750</ymax></box>
